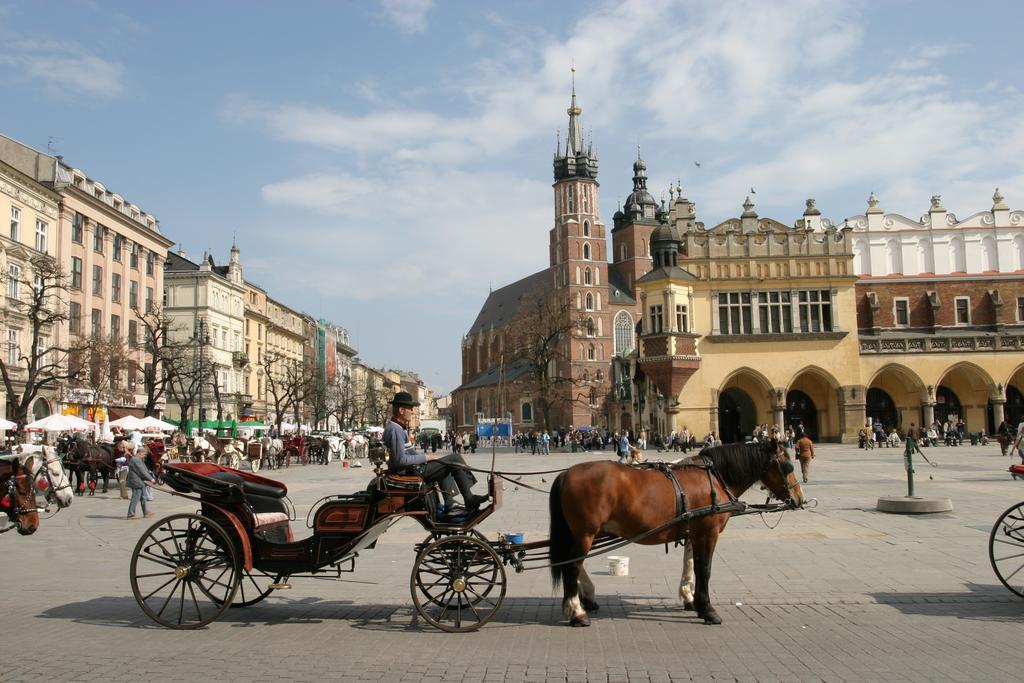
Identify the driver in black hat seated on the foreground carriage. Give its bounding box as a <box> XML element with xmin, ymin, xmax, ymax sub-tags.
<box><xmin>382</xmin><ymin>391</ymin><xmax>487</xmax><ymax>512</ymax></box>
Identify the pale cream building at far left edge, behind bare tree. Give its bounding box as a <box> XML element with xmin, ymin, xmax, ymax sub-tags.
<box><xmin>0</xmin><ymin>148</ymin><xmax>60</xmax><ymax>420</ymax></box>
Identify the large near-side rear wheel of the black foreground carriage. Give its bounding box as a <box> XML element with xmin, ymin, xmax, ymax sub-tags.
<box><xmin>131</xmin><ymin>514</ymin><xmax>242</xmax><ymax>629</ymax></box>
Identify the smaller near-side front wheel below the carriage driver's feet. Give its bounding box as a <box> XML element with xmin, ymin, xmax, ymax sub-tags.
<box><xmin>410</xmin><ymin>536</ymin><xmax>506</xmax><ymax>633</ymax></box>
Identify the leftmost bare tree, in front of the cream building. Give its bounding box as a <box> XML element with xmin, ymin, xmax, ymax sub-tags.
<box><xmin>0</xmin><ymin>254</ymin><xmax>81</xmax><ymax>430</ymax></box>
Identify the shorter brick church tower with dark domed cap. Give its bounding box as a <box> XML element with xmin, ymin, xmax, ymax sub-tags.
<box><xmin>611</xmin><ymin>150</ymin><xmax>658</xmax><ymax>294</ymax></box>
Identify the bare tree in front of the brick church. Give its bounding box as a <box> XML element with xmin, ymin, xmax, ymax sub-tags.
<box><xmin>505</xmin><ymin>288</ymin><xmax>587</xmax><ymax>429</ymax></box>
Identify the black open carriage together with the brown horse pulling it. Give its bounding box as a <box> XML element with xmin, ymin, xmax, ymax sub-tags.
<box><xmin>131</xmin><ymin>443</ymin><xmax>804</xmax><ymax>632</ymax></box>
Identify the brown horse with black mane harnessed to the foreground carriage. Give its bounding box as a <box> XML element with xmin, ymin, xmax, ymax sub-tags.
<box><xmin>549</xmin><ymin>439</ymin><xmax>804</xmax><ymax>626</ymax></box>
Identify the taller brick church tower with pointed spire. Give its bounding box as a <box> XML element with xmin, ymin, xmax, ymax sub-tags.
<box><xmin>549</xmin><ymin>69</ymin><xmax>613</xmax><ymax>427</ymax></box>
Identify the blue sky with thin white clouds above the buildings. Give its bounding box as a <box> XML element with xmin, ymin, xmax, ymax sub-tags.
<box><xmin>0</xmin><ymin>0</ymin><xmax>1024</xmax><ymax>391</ymax></box>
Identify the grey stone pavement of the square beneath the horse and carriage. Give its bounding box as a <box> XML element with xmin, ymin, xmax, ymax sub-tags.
<box><xmin>6</xmin><ymin>445</ymin><xmax>1024</xmax><ymax>683</ymax></box>
